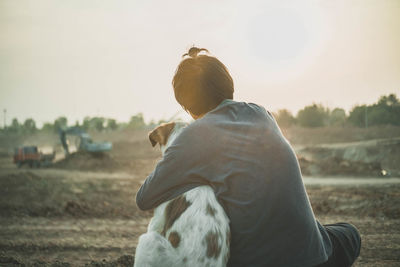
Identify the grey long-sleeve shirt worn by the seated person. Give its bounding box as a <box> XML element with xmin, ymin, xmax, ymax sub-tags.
<box><xmin>136</xmin><ymin>100</ymin><xmax>332</xmax><ymax>267</ymax></box>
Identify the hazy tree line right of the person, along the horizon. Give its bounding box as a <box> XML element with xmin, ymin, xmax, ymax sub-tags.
<box><xmin>274</xmin><ymin>94</ymin><xmax>400</xmax><ymax>128</ymax></box>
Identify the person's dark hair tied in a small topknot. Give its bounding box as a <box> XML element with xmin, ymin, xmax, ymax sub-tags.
<box><xmin>172</xmin><ymin>47</ymin><xmax>234</xmax><ymax>115</ymax></box>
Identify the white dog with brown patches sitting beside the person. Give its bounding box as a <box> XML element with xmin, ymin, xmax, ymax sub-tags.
<box><xmin>134</xmin><ymin>122</ymin><xmax>230</xmax><ymax>267</ymax></box>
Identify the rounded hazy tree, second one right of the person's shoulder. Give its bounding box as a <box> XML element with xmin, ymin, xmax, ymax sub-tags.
<box><xmin>297</xmin><ymin>104</ymin><xmax>329</xmax><ymax>127</ymax></box>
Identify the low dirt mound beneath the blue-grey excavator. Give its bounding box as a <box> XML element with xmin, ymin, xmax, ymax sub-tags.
<box><xmin>52</xmin><ymin>151</ymin><xmax>121</xmax><ymax>170</ymax></box>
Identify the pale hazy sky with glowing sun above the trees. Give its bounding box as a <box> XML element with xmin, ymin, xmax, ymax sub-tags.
<box><xmin>0</xmin><ymin>0</ymin><xmax>400</xmax><ymax>126</ymax></box>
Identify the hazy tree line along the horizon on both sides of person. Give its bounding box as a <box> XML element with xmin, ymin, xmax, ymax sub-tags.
<box><xmin>1</xmin><ymin>94</ymin><xmax>400</xmax><ymax>134</ymax></box>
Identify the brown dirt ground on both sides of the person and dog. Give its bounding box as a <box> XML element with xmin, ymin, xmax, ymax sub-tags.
<box><xmin>0</xmin><ymin>129</ymin><xmax>400</xmax><ymax>266</ymax></box>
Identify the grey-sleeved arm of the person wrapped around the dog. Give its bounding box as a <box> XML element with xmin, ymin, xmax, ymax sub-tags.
<box><xmin>136</xmin><ymin>125</ymin><xmax>210</xmax><ymax>210</ymax></box>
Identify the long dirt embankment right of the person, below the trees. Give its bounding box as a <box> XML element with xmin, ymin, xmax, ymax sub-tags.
<box><xmin>297</xmin><ymin>138</ymin><xmax>400</xmax><ymax>177</ymax></box>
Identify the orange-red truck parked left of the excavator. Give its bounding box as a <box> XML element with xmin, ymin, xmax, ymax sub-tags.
<box><xmin>13</xmin><ymin>146</ymin><xmax>56</xmax><ymax>168</ymax></box>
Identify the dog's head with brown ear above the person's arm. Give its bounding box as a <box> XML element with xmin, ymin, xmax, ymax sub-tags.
<box><xmin>149</xmin><ymin>122</ymin><xmax>186</xmax><ymax>153</ymax></box>
